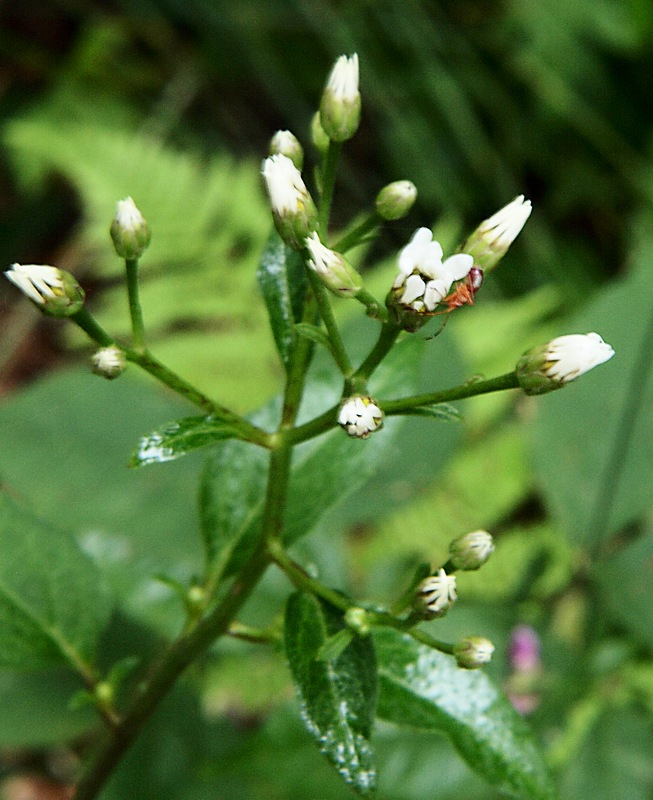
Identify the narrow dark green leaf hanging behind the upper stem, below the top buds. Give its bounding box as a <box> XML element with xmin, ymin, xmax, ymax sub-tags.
<box><xmin>256</xmin><ymin>231</ymin><xmax>306</xmax><ymax>369</ymax></box>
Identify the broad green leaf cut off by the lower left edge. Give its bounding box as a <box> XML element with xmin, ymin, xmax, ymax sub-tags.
<box><xmin>0</xmin><ymin>494</ymin><xmax>110</xmax><ymax>669</ymax></box>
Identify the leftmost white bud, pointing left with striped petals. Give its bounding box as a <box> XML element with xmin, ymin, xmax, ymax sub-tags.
<box><xmin>5</xmin><ymin>264</ymin><xmax>84</xmax><ymax>317</ymax></box>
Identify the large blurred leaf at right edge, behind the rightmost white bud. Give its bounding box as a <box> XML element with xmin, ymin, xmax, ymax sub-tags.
<box><xmin>529</xmin><ymin>260</ymin><xmax>653</xmax><ymax>547</ymax></box>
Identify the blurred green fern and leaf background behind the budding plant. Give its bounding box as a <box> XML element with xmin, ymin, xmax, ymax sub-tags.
<box><xmin>0</xmin><ymin>0</ymin><xmax>653</xmax><ymax>800</ymax></box>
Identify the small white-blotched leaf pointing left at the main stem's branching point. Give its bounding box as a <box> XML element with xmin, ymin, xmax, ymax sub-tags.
<box><xmin>129</xmin><ymin>416</ymin><xmax>238</xmax><ymax>467</ymax></box>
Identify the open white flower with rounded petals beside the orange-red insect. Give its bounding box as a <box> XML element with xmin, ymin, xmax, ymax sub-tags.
<box><xmin>393</xmin><ymin>228</ymin><xmax>474</xmax><ymax>311</ymax></box>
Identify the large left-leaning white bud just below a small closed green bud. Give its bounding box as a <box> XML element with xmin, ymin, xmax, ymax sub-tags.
<box><xmin>262</xmin><ymin>154</ymin><xmax>317</xmax><ymax>250</ymax></box>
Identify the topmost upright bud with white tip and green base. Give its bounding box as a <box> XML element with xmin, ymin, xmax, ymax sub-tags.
<box><xmin>320</xmin><ymin>53</ymin><xmax>361</xmax><ymax>142</ymax></box>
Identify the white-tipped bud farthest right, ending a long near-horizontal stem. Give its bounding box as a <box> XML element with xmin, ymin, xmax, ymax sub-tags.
<box><xmin>515</xmin><ymin>333</ymin><xmax>614</xmax><ymax>395</ymax></box>
